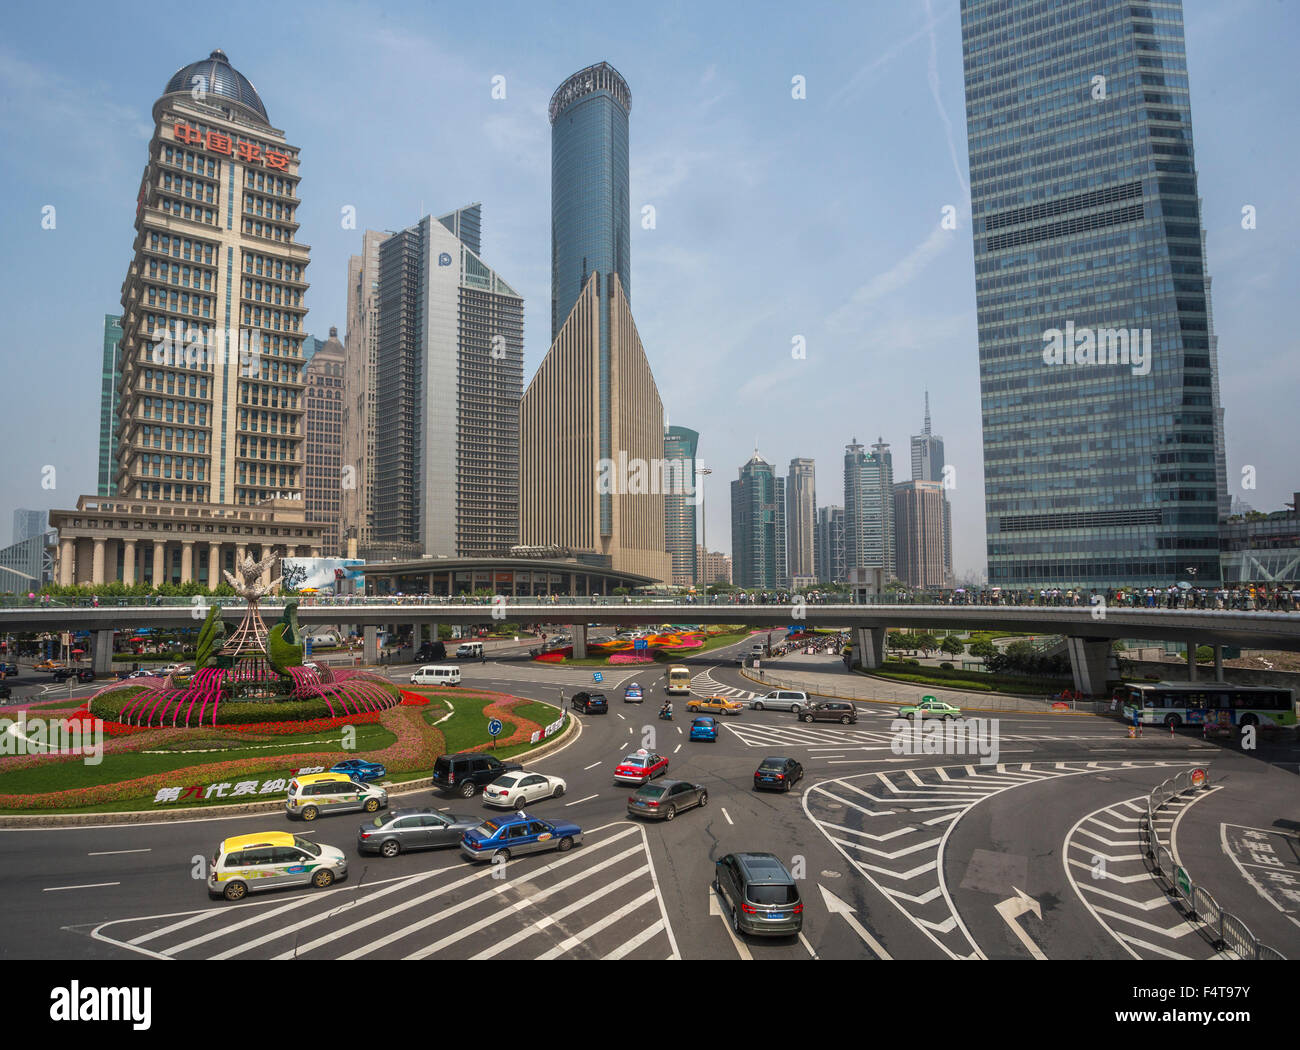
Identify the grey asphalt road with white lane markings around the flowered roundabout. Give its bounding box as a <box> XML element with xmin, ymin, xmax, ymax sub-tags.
<box><xmin>0</xmin><ymin>642</ymin><xmax>1300</xmax><ymax>959</ymax></box>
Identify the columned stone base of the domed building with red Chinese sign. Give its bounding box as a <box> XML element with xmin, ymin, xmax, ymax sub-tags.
<box><xmin>49</xmin><ymin>496</ymin><xmax>329</xmax><ymax>590</ymax></box>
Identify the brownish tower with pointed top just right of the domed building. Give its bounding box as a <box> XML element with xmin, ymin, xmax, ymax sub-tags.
<box><xmin>303</xmin><ymin>327</ymin><xmax>346</xmax><ymax>557</ymax></box>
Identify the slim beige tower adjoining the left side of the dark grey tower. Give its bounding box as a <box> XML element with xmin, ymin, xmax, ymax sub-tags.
<box><xmin>342</xmin><ymin>230</ymin><xmax>391</xmax><ymax>551</ymax></box>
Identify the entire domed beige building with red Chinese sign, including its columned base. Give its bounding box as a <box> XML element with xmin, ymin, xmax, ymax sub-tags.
<box><xmin>49</xmin><ymin>49</ymin><xmax>324</xmax><ymax>586</ymax></box>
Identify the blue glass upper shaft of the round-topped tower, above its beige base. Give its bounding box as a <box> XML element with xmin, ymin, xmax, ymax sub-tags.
<box><xmin>550</xmin><ymin>62</ymin><xmax>632</xmax><ymax>339</ymax></box>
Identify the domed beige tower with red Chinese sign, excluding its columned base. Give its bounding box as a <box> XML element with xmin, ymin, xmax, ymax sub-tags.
<box><xmin>117</xmin><ymin>51</ymin><xmax>309</xmax><ymax>507</ymax></box>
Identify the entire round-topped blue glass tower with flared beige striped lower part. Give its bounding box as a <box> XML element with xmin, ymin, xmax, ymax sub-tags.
<box><xmin>520</xmin><ymin>62</ymin><xmax>672</xmax><ymax>581</ymax></box>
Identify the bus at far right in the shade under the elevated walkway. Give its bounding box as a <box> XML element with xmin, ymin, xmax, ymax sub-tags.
<box><xmin>1112</xmin><ymin>682</ymin><xmax>1296</xmax><ymax>729</ymax></box>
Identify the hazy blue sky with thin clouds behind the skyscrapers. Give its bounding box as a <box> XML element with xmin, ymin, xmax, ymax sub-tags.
<box><xmin>0</xmin><ymin>0</ymin><xmax>1300</xmax><ymax>572</ymax></box>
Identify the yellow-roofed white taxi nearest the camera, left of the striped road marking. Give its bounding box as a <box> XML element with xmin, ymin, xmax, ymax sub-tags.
<box><xmin>208</xmin><ymin>832</ymin><xmax>347</xmax><ymax>901</ymax></box>
